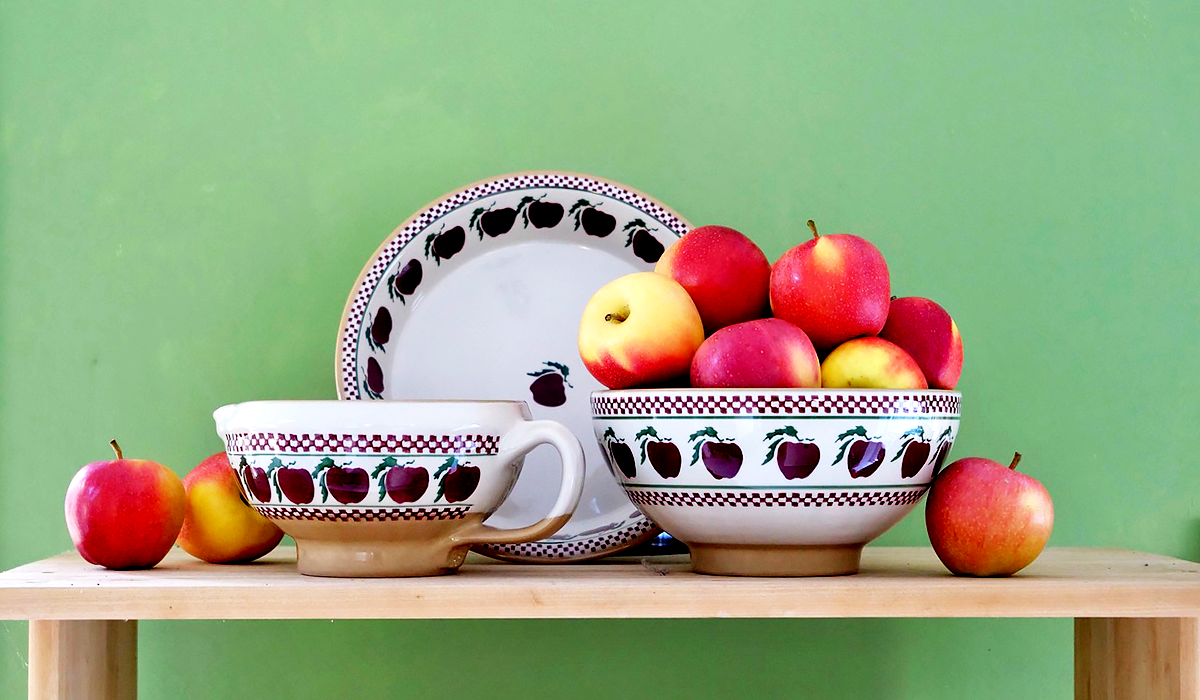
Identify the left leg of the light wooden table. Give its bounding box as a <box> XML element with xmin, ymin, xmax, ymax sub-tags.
<box><xmin>29</xmin><ymin>620</ymin><xmax>138</xmax><ymax>700</ymax></box>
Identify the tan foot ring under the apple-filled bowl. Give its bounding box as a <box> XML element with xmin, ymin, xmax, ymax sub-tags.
<box><xmin>688</xmin><ymin>543</ymin><xmax>864</xmax><ymax>576</ymax></box>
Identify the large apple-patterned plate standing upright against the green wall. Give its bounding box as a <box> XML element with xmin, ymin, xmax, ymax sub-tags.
<box><xmin>337</xmin><ymin>172</ymin><xmax>689</xmax><ymax>562</ymax></box>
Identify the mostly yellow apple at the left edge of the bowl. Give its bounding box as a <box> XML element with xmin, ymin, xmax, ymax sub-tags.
<box><xmin>578</xmin><ymin>273</ymin><xmax>704</xmax><ymax>389</ymax></box>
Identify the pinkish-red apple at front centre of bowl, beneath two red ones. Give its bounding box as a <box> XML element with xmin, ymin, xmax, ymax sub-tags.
<box><xmin>691</xmin><ymin>318</ymin><xmax>821</xmax><ymax>388</ymax></box>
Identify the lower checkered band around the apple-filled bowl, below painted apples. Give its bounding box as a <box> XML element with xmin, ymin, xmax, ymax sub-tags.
<box><xmin>626</xmin><ymin>486</ymin><xmax>926</xmax><ymax>508</ymax></box>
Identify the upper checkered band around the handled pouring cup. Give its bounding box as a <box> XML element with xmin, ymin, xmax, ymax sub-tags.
<box><xmin>228</xmin><ymin>432</ymin><xmax>500</xmax><ymax>455</ymax></box>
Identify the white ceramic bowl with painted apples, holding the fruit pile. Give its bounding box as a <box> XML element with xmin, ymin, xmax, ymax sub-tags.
<box><xmin>592</xmin><ymin>389</ymin><xmax>961</xmax><ymax>576</ymax></box>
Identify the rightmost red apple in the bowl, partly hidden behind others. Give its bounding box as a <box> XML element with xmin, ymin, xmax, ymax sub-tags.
<box><xmin>880</xmin><ymin>297</ymin><xmax>962</xmax><ymax>389</ymax></box>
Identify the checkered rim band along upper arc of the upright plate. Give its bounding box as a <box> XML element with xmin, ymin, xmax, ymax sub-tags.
<box><xmin>337</xmin><ymin>173</ymin><xmax>689</xmax><ymax>399</ymax></box>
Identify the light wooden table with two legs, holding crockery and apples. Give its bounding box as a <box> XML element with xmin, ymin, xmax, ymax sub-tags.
<box><xmin>0</xmin><ymin>546</ymin><xmax>1200</xmax><ymax>700</ymax></box>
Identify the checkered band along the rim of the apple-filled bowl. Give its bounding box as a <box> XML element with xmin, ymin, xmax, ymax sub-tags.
<box><xmin>592</xmin><ymin>391</ymin><xmax>961</xmax><ymax>417</ymax></box>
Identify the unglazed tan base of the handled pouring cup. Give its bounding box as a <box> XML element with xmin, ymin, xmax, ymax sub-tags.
<box><xmin>276</xmin><ymin>515</ymin><xmax>481</xmax><ymax>578</ymax></box>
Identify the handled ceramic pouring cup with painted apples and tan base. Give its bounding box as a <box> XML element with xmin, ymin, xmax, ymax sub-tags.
<box><xmin>214</xmin><ymin>401</ymin><xmax>583</xmax><ymax>576</ymax></box>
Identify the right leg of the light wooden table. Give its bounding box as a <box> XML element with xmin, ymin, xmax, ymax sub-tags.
<box><xmin>1075</xmin><ymin>617</ymin><xmax>1200</xmax><ymax>700</ymax></box>
